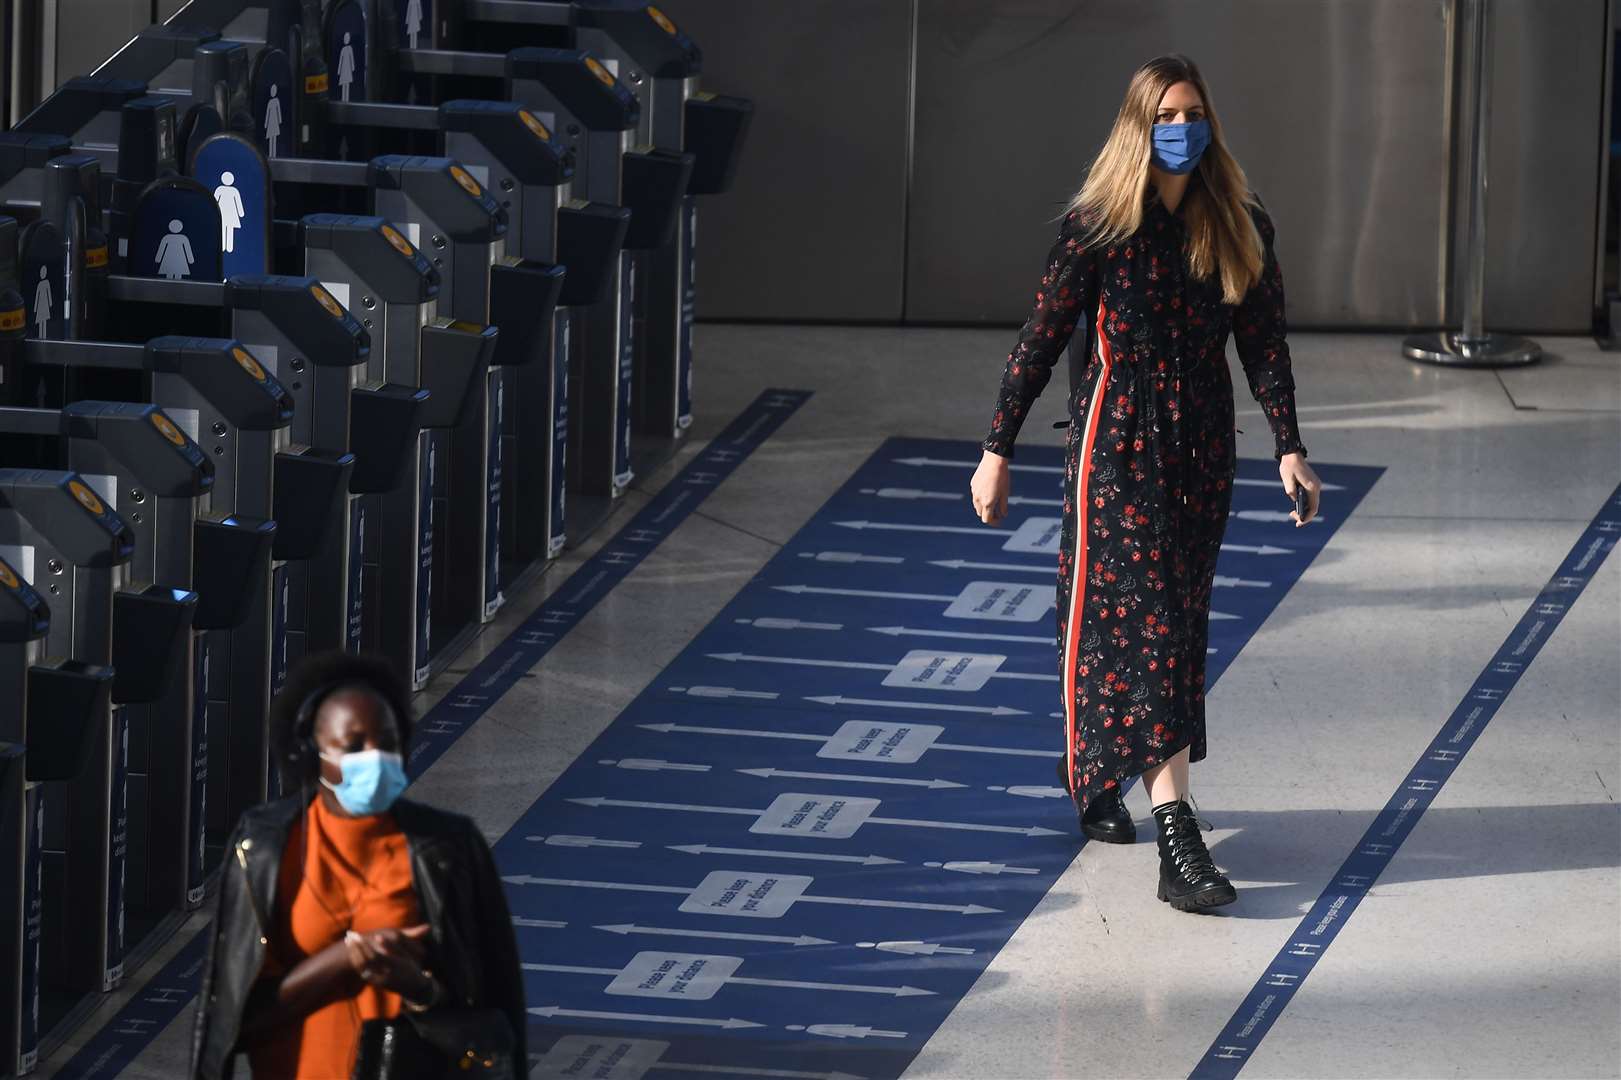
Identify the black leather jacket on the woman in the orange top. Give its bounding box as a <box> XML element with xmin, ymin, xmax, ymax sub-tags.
<box><xmin>191</xmin><ymin>795</ymin><xmax>528</xmax><ymax>1080</ymax></box>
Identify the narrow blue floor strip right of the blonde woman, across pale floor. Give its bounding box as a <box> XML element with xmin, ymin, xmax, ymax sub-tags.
<box><xmin>1190</xmin><ymin>486</ymin><xmax>1621</xmax><ymax>1080</ymax></box>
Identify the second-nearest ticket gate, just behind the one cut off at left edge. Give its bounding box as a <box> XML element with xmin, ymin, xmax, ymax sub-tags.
<box><xmin>0</xmin><ymin>469</ymin><xmax>134</xmax><ymax>994</ymax></box>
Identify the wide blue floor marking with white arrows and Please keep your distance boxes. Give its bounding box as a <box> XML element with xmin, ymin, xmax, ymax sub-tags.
<box><xmin>518</xmin><ymin>439</ymin><xmax>1383</xmax><ymax>1080</ymax></box>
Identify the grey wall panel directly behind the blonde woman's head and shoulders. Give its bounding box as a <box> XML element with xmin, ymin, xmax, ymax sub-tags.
<box><xmin>906</xmin><ymin>0</ymin><xmax>1448</xmax><ymax>326</ymax></box>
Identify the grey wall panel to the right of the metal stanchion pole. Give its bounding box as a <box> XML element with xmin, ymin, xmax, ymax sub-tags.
<box><xmin>1478</xmin><ymin>0</ymin><xmax>1608</xmax><ymax>334</ymax></box>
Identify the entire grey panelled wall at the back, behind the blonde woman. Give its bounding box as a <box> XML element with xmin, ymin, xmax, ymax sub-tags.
<box><xmin>663</xmin><ymin>0</ymin><xmax>1608</xmax><ymax>332</ymax></box>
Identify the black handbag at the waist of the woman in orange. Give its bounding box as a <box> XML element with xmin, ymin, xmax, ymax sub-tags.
<box><xmin>352</xmin><ymin>1009</ymin><xmax>517</xmax><ymax>1080</ymax></box>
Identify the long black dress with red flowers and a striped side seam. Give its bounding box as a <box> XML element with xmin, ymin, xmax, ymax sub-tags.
<box><xmin>982</xmin><ymin>174</ymin><xmax>1305</xmax><ymax>812</ymax></box>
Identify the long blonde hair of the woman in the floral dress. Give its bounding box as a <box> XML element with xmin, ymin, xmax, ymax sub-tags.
<box><xmin>1067</xmin><ymin>52</ymin><xmax>1264</xmax><ymax>303</ymax></box>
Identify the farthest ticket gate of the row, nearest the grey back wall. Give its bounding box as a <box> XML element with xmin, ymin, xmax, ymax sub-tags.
<box><xmin>457</xmin><ymin>0</ymin><xmax>754</xmax><ymax>438</ymax></box>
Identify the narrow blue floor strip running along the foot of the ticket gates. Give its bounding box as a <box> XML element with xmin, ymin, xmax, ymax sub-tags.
<box><xmin>57</xmin><ymin>389</ymin><xmax>811</xmax><ymax>1080</ymax></box>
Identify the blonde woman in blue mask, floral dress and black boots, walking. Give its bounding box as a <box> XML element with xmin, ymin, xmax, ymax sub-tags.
<box><xmin>971</xmin><ymin>54</ymin><xmax>1319</xmax><ymax>911</ymax></box>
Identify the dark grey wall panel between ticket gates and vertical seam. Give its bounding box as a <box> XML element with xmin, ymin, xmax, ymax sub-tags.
<box><xmin>661</xmin><ymin>0</ymin><xmax>911</xmax><ymax>321</ymax></box>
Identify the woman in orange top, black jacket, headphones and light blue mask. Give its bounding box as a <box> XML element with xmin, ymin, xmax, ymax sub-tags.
<box><xmin>191</xmin><ymin>654</ymin><xmax>525</xmax><ymax>1080</ymax></box>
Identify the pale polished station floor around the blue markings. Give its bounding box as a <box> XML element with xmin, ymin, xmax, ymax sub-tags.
<box><xmin>44</xmin><ymin>324</ymin><xmax>1621</xmax><ymax>1080</ymax></box>
